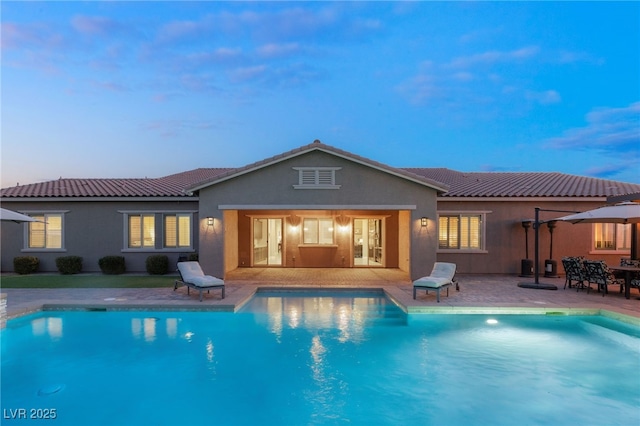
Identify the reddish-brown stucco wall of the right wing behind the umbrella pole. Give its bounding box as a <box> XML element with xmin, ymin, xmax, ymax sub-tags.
<box><xmin>437</xmin><ymin>198</ymin><xmax>628</xmax><ymax>274</ymax></box>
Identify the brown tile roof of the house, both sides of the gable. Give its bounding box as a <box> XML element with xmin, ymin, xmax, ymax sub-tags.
<box><xmin>0</xmin><ymin>160</ymin><xmax>640</xmax><ymax>198</ymax></box>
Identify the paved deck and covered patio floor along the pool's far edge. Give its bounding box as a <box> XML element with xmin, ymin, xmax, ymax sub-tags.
<box><xmin>2</xmin><ymin>268</ymin><xmax>640</xmax><ymax>325</ymax></box>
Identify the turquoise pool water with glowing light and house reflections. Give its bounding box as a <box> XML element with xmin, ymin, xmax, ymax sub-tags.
<box><xmin>1</xmin><ymin>292</ymin><xmax>640</xmax><ymax>425</ymax></box>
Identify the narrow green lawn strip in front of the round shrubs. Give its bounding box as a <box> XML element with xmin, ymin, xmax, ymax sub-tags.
<box><xmin>0</xmin><ymin>274</ymin><xmax>176</xmax><ymax>288</ymax></box>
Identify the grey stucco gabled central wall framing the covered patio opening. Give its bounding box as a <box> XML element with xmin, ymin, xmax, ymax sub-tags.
<box><xmin>199</xmin><ymin>151</ymin><xmax>437</xmax><ymax>277</ymax></box>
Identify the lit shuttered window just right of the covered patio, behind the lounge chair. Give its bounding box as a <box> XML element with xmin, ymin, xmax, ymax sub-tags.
<box><xmin>438</xmin><ymin>214</ymin><xmax>483</xmax><ymax>250</ymax></box>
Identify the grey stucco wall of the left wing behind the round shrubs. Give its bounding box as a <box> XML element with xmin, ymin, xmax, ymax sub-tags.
<box><xmin>0</xmin><ymin>200</ymin><xmax>199</xmax><ymax>272</ymax></box>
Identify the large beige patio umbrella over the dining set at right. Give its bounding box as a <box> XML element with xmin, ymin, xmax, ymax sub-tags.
<box><xmin>556</xmin><ymin>202</ymin><xmax>640</xmax><ymax>259</ymax></box>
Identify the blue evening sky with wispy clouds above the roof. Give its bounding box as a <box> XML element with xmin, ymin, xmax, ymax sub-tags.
<box><xmin>0</xmin><ymin>1</ymin><xmax>640</xmax><ymax>187</ymax></box>
